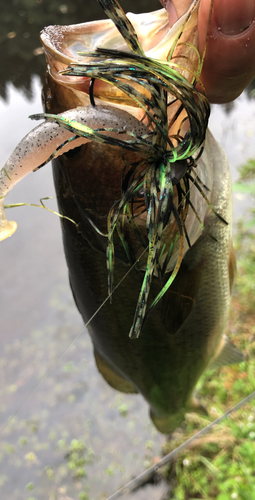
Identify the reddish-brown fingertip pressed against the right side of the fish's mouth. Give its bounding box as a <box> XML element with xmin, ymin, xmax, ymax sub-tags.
<box><xmin>198</xmin><ymin>0</ymin><xmax>255</xmax><ymax>103</ymax></box>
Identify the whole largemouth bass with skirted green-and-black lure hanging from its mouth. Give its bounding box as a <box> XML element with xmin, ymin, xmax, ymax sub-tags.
<box><xmin>0</xmin><ymin>0</ymin><xmax>243</xmax><ymax>433</ymax></box>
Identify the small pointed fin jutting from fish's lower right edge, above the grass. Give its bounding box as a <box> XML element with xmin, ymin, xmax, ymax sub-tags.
<box><xmin>207</xmin><ymin>335</ymin><xmax>245</xmax><ymax>370</ymax></box>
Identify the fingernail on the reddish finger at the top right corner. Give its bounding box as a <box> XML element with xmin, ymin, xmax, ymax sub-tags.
<box><xmin>214</xmin><ymin>0</ymin><xmax>255</xmax><ymax>36</ymax></box>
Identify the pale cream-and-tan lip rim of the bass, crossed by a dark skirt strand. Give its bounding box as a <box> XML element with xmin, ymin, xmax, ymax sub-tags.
<box><xmin>40</xmin><ymin>9</ymin><xmax>189</xmax><ymax>65</ymax></box>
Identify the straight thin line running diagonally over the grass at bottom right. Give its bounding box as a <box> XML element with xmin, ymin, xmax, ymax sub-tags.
<box><xmin>106</xmin><ymin>391</ymin><xmax>255</xmax><ymax>500</ymax></box>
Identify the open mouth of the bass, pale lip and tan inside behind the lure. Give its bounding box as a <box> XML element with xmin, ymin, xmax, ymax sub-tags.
<box><xmin>40</xmin><ymin>0</ymin><xmax>205</xmax><ymax>109</ymax></box>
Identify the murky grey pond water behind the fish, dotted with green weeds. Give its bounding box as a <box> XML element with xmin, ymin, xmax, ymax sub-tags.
<box><xmin>0</xmin><ymin>1</ymin><xmax>255</xmax><ymax>500</ymax></box>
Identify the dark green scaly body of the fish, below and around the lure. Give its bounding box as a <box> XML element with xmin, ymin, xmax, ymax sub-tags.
<box><xmin>47</xmin><ymin>123</ymin><xmax>234</xmax><ymax>433</ymax></box>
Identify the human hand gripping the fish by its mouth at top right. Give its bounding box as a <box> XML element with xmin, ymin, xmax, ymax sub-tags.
<box><xmin>160</xmin><ymin>0</ymin><xmax>255</xmax><ymax>103</ymax></box>
